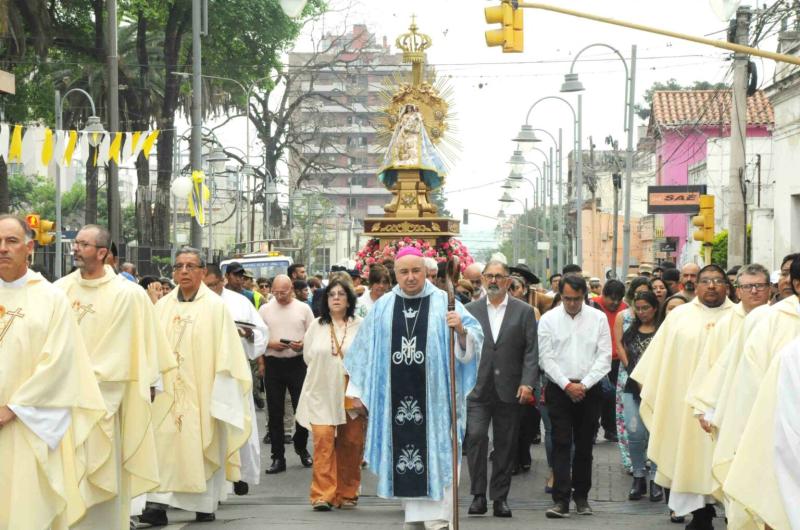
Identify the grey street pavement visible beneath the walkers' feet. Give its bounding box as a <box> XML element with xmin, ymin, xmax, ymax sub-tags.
<box><xmin>140</xmin><ymin>411</ymin><xmax>700</xmax><ymax>530</ymax></box>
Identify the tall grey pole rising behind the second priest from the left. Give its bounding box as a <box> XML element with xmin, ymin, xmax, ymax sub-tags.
<box><xmin>106</xmin><ymin>0</ymin><xmax>122</xmax><ymax>246</ymax></box>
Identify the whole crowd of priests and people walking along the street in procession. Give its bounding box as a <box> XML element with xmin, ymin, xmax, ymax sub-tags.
<box><xmin>0</xmin><ymin>211</ymin><xmax>800</xmax><ymax>530</ymax></box>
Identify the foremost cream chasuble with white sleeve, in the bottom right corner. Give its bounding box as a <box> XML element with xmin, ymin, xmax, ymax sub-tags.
<box><xmin>723</xmin><ymin>339</ymin><xmax>800</xmax><ymax>530</ymax></box>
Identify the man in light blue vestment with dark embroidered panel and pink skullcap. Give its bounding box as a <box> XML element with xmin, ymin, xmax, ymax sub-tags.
<box><xmin>345</xmin><ymin>247</ymin><xmax>483</xmax><ymax>529</ymax></box>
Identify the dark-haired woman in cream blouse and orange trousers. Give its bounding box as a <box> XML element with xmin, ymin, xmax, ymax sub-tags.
<box><xmin>296</xmin><ymin>278</ymin><xmax>366</xmax><ymax>511</ymax></box>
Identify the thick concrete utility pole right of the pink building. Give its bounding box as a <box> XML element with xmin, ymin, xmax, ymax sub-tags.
<box><xmin>726</xmin><ymin>6</ymin><xmax>752</xmax><ymax>267</ymax></box>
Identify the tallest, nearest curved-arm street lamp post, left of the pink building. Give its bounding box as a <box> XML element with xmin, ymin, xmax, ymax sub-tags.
<box><xmin>561</xmin><ymin>43</ymin><xmax>636</xmax><ymax>277</ymax></box>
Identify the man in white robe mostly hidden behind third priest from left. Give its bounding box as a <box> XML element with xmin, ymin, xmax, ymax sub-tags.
<box><xmin>203</xmin><ymin>265</ymin><xmax>269</xmax><ymax>495</ymax></box>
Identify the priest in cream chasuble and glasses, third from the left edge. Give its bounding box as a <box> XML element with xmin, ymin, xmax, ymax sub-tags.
<box><xmin>139</xmin><ymin>247</ymin><xmax>252</xmax><ymax>526</ymax></box>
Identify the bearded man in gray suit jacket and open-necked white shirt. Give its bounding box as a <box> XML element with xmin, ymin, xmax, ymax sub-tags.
<box><xmin>464</xmin><ymin>261</ymin><xmax>539</xmax><ymax>517</ymax></box>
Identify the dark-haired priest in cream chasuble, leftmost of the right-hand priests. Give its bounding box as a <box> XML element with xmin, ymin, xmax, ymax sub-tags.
<box><xmin>631</xmin><ymin>265</ymin><xmax>733</xmax><ymax>530</ymax></box>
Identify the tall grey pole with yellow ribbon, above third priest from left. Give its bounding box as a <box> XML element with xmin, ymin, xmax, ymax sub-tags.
<box><xmin>189</xmin><ymin>0</ymin><xmax>203</xmax><ymax>250</ymax></box>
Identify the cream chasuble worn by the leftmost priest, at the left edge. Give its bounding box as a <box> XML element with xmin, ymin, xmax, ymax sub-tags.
<box><xmin>0</xmin><ymin>271</ymin><xmax>106</xmax><ymax>530</ymax></box>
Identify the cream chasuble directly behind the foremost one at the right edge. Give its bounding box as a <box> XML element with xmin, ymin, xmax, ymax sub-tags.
<box><xmin>712</xmin><ymin>296</ymin><xmax>800</xmax><ymax>524</ymax></box>
